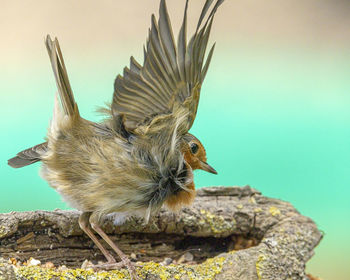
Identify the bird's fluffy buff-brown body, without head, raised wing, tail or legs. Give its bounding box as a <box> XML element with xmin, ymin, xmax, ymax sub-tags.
<box><xmin>41</xmin><ymin>103</ymin><xmax>194</xmax><ymax>220</ymax></box>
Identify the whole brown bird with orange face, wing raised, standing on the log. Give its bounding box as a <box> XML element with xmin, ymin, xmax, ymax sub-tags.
<box><xmin>8</xmin><ymin>0</ymin><xmax>223</xmax><ymax>278</ymax></box>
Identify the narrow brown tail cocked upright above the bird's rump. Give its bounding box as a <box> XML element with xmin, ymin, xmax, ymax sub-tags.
<box><xmin>45</xmin><ymin>35</ymin><xmax>79</xmax><ymax>116</ymax></box>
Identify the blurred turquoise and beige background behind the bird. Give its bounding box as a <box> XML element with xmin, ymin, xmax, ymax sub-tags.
<box><xmin>0</xmin><ymin>0</ymin><xmax>350</xmax><ymax>280</ymax></box>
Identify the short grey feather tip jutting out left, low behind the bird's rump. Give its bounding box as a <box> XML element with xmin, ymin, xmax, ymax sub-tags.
<box><xmin>7</xmin><ymin>142</ymin><xmax>47</xmax><ymax>168</ymax></box>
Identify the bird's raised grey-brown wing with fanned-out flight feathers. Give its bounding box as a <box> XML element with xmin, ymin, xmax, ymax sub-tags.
<box><xmin>111</xmin><ymin>0</ymin><xmax>224</xmax><ymax>134</ymax></box>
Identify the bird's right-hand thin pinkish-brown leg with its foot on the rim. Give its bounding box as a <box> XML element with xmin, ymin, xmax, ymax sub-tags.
<box><xmin>89</xmin><ymin>215</ymin><xmax>138</xmax><ymax>280</ymax></box>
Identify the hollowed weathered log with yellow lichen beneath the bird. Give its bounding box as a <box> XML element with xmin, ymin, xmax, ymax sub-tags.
<box><xmin>0</xmin><ymin>186</ymin><xmax>322</xmax><ymax>280</ymax></box>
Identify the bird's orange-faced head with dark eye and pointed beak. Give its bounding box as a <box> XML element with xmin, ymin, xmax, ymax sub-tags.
<box><xmin>182</xmin><ymin>133</ymin><xmax>218</xmax><ymax>174</ymax></box>
